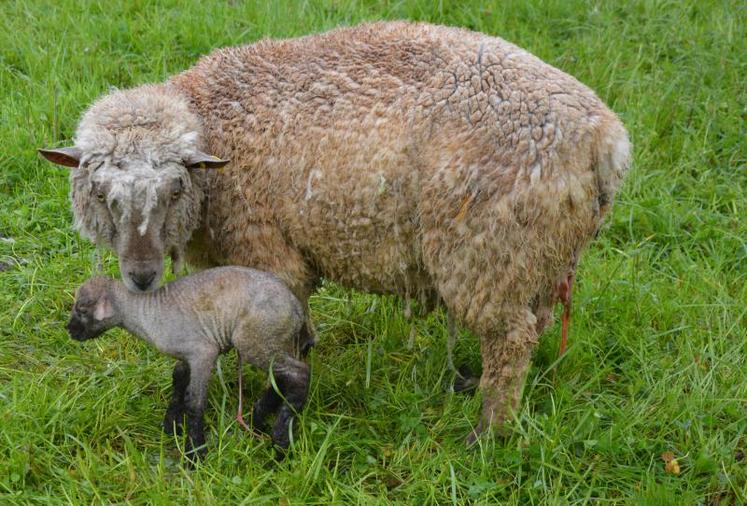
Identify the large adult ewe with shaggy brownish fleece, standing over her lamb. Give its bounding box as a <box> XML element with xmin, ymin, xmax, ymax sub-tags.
<box><xmin>42</xmin><ymin>22</ymin><xmax>630</xmax><ymax>442</ymax></box>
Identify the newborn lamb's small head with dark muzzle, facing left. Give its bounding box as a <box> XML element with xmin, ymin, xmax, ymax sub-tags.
<box><xmin>67</xmin><ymin>277</ymin><xmax>118</xmax><ymax>341</ymax></box>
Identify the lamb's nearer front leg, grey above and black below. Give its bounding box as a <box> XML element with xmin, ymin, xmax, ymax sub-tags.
<box><xmin>184</xmin><ymin>350</ymin><xmax>218</xmax><ymax>460</ymax></box>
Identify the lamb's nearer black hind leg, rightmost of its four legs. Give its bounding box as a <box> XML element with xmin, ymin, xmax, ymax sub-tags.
<box><xmin>272</xmin><ymin>358</ymin><xmax>310</xmax><ymax>460</ymax></box>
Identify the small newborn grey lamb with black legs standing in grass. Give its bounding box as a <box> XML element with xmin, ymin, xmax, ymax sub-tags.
<box><xmin>68</xmin><ymin>267</ymin><xmax>314</xmax><ymax>458</ymax></box>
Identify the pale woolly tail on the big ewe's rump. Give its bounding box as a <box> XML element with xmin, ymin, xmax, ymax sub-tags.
<box><xmin>592</xmin><ymin>117</ymin><xmax>631</xmax><ymax>216</ymax></box>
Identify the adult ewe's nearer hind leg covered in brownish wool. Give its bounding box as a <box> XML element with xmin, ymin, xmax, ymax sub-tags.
<box><xmin>467</xmin><ymin>306</ymin><xmax>538</xmax><ymax>444</ymax></box>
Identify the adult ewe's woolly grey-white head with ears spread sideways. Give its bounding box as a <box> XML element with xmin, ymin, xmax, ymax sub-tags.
<box><xmin>40</xmin><ymin>85</ymin><xmax>228</xmax><ymax>292</ymax></box>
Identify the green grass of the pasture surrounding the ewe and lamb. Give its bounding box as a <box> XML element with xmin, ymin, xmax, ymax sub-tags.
<box><xmin>0</xmin><ymin>0</ymin><xmax>747</xmax><ymax>505</ymax></box>
